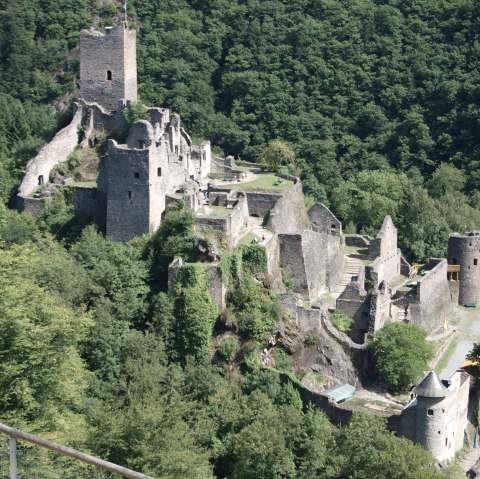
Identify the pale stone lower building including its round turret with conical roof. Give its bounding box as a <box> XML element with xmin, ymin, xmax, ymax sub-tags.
<box><xmin>399</xmin><ymin>371</ymin><xmax>470</xmax><ymax>463</ymax></box>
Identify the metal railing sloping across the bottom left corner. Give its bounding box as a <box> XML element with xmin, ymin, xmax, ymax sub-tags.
<box><xmin>0</xmin><ymin>423</ymin><xmax>153</xmax><ymax>479</ymax></box>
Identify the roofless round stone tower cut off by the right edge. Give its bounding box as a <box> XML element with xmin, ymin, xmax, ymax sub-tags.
<box><xmin>448</xmin><ymin>231</ymin><xmax>480</xmax><ymax>305</ymax></box>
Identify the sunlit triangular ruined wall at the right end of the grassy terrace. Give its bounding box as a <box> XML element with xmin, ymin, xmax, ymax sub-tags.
<box><xmin>264</xmin><ymin>181</ymin><xmax>310</xmax><ymax>234</ymax></box>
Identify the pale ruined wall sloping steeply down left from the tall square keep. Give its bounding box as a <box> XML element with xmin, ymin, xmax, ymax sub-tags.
<box><xmin>18</xmin><ymin>103</ymin><xmax>82</xmax><ymax>202</ymax></box>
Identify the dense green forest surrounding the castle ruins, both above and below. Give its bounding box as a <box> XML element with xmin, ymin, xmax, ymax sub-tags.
<box><xmin>0</xmin><ymin>0</ymin><xmax>480</xmax><ymax>479</ymax></box>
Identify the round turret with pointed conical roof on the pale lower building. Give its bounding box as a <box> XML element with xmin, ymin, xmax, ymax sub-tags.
<box><xmin>415</xmin><ymin>371</ymin><xmax>449</xmax><ymax>460</ymax></box>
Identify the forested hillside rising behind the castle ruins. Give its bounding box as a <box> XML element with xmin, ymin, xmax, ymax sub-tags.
<box><xmin>0</xmin><ymin>0</ymin><xmax>480</xmax><ymax>260</ymax></box>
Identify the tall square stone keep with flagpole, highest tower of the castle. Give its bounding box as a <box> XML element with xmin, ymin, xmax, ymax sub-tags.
<box><xmin>80</xmin><ymin>22</ymin><xmax>137</xmax><ymax>110</ymax></box>
